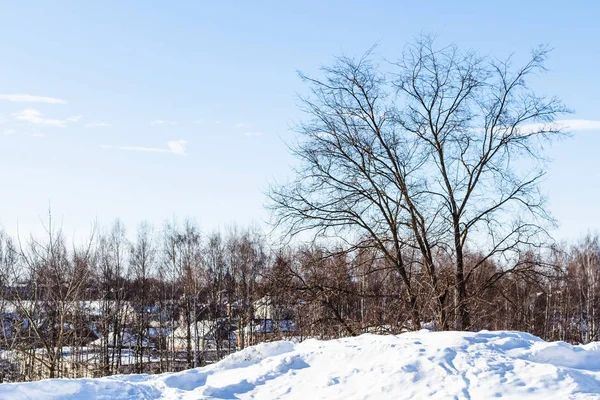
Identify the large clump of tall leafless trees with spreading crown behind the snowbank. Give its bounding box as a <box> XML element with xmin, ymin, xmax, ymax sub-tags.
<box><xmin>270</xmin><ymin>37</ymin><xmax>569</xmax><ymax>329</ymax></box>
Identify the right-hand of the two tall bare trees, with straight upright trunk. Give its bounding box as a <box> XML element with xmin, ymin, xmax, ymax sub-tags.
<box><xmin>393</xmin><ymin>37</ymin><xmax>568</xmax><ymax>329</ymax></box>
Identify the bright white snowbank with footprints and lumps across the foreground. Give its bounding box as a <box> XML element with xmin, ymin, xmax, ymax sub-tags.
<box><xmin>0</xmin><ymin>331</ymin><xmax>600</xmax><ymax>400</ymax></box>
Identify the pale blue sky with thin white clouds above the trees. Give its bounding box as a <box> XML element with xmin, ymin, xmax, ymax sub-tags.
<box><xmin>0</xmin><ymin>1</ymin><xmax>600</xmax><ymax>240</ymax></box>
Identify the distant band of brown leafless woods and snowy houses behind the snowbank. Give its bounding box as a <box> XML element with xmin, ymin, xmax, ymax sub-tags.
<box><xmin>0</xmin><ymin>217</ymin><xmax>600</xmax><ymax>381</ymax></box>
